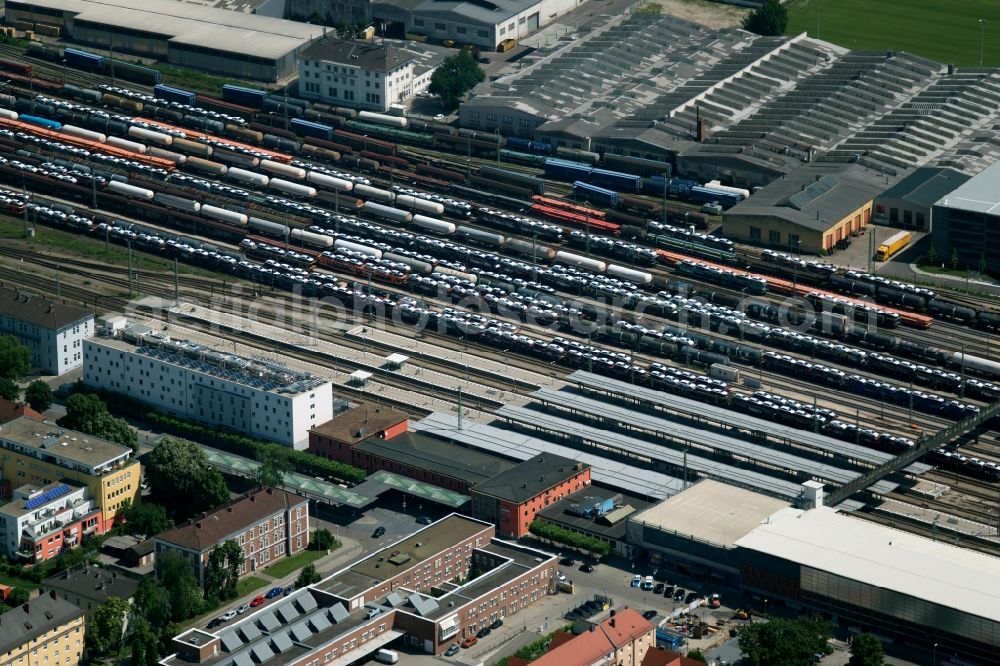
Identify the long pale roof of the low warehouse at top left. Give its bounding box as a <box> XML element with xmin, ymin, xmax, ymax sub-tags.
<box><xmin>19</xmin><ymin>0</ymin><xmax>322</xmax><ymax>59</ymax></box>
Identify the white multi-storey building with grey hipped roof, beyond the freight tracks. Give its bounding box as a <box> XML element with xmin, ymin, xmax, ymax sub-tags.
<box><xmin>299</xmin><ymin>39</ymin><xmax>422</xmax><ymax>112</ymax></box>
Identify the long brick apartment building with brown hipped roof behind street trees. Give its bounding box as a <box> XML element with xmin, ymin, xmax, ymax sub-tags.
<box><xmin>153</xmin><ymin>488</ymin><xmax>309</xmax><ymax>586</ymax></box>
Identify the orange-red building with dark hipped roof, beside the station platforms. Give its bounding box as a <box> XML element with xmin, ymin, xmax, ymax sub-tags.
<box><xmin>469</xmin><ymin>453</ymin><xmax>590</xmax><ymax>539</ymax></box>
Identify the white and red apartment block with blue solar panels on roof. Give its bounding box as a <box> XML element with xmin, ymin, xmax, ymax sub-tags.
<box><xmin>0</xmin><ymin>481</ymin><xmax>102</xmax><ymax>564</ymax></box>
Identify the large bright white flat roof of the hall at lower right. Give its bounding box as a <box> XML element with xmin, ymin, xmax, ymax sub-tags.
<box><xmin>736</xmin><ymin>507</ymin><xmax>1000</xmax><ymax>622</ymax></box>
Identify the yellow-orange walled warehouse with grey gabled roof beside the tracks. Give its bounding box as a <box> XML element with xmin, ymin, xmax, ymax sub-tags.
<box><xmin>722</xmin><ymin>164</ymin><xmax>887</xmax><ymax>254</ymax></box>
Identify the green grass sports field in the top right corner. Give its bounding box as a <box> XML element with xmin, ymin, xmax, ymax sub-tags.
<box><xmin>788</xmin><ymin>0</ymin><xmax>1000</xmax><ymax>67</ymax></box>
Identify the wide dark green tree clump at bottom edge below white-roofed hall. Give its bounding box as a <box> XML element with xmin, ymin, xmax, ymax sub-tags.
<box><xmin>739</xmin><ymin>617</ymin><xmax>830</xmax><ymax>666</ymax></box>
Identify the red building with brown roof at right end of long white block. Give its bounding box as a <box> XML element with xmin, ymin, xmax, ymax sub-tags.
<box><xmin>308</xmin><ymin>404</ymin><xmax>409</xmax><ymax>465</ymax></box>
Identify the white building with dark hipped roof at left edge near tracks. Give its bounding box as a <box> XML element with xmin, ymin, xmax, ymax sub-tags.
<box><xmin>0</xmin><ymin>287</ymin><xmax>94</xmax><ymax>375</ymax></box>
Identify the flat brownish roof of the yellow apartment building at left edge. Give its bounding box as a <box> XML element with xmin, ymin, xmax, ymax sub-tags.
<box><xmin>0</xmin><ymin>416</ymin><xmax>132</xmax><ymax>469</ymax></box>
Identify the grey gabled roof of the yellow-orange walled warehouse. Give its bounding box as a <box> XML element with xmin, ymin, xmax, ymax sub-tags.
<box><xmin>723</xmin><ymin>163</ymin><xmax>885</xmax><ymax>231</ymax></box>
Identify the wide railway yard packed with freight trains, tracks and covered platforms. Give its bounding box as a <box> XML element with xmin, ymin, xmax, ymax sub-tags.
<box><xmin>0</xmin><ymin>47</ymin><xmax>1000</xmax><ymax>554</ymax></box>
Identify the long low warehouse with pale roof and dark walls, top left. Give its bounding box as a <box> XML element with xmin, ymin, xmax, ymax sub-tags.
<box><xmin>6</xmin><ymin>0</ymin><xmax>322</xmax><ymax>83</ymax></box>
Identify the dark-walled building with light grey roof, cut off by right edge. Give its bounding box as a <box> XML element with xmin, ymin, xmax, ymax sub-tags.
<box><xmin>931</xmin><ymin>162</ymin><xmax>1000</xmax><ymax>275</ymax></box>
